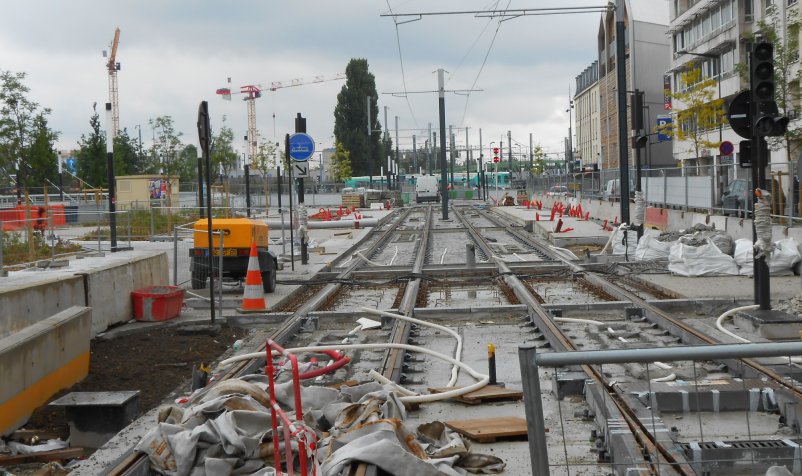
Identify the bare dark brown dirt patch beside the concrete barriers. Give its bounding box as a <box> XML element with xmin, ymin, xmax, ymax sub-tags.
<box><xmin>25</xmin><ymin>327</ymin><xmax>247</xmax><ymax>438</ymax></box>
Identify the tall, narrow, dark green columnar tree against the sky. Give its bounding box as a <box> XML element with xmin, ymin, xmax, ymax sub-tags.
<box><xmin>334</xmin><ymin>58</ymin><xmax>383</xmax><ymax>175</ymax></box>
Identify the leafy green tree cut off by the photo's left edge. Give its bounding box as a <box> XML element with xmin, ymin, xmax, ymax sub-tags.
<box><xmin>0</xmin><ymin>70</ymin><xmax>58</xmax><ymax>192</ymax></box>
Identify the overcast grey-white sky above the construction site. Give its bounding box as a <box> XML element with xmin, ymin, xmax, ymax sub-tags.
<box><xmin>0</xmin><ymin>0</ymin><xmax>624</xmax><ymax>163</ymax></box>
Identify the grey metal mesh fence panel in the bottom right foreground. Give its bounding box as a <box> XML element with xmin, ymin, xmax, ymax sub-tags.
<box><xmin>518</xmin><ymin>342</ymin><xmax>802</xmax><ymax>475</ymax></box>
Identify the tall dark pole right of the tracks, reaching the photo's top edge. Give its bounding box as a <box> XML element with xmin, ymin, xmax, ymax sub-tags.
<box><xmin>615</xmin><ymin>0</ymin><xmax>630</xmax><ymax>223</ymax></box>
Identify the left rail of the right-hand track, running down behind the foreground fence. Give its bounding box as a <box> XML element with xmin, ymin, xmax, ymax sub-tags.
<box><xmin>454</xmin><ymin>209</ymin><xmax>696</xmax><ymax>475</ymax></box>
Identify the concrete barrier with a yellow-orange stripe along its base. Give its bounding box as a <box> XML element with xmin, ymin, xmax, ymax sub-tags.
<box><xmin>0</xmin><ymin>306</ymin><xmax>92</xmax><ymax>435</ymax></box>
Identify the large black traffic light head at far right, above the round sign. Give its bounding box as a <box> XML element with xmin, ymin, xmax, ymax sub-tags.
<box><xmin>749</xmin><ymin>41</ymin><xmax>788</xmax><ymax>136</ymax></box>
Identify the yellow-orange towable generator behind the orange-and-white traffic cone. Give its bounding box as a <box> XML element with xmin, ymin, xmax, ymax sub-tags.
<box><xmin>189</xmin><ymin>218</ymin><xmax>278</xmax><ymax>293</ymax></box>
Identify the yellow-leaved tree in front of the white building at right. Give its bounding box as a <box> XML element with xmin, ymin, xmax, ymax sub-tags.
<box><xmin>656</xmin><ymin>66</ymin><xmax>726</xmax><ymax>165</ymax></box>
